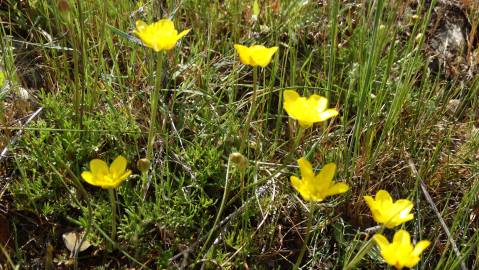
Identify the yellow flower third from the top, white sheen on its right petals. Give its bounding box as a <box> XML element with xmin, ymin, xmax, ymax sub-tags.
<box><xmin>283</xmin><ymin>90</ymin><xmax>338</xmax><ymax>128</ymax></box>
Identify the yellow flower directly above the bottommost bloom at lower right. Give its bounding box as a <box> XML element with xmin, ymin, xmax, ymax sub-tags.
<box><xmin>364</xmin><ymin>190</ymin><xmax>414</xmax><ymax>229</ymax></box>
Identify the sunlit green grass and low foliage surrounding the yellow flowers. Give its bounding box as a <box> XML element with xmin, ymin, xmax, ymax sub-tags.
<box><xmin>0</xmin><ymin>0</ymin><xmax>479</xmax><ymax>269</ymax></box>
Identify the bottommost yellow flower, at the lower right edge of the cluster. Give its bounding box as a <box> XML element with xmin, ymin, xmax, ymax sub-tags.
<box><xmin>373</xmin><ymin>230</ymin><xmax>431</xmax><ymax>269</ymax></box>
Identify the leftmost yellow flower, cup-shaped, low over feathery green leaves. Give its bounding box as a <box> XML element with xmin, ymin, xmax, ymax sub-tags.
<box><xmin>81</xmin><ymin>156</ymin><xmax>131</xmax><ymax>189</ymax></box>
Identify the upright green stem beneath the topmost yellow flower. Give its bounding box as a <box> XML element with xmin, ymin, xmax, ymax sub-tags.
<box><xmin>146</xmin><ymin>52</ymin><xmax>163</xmax><ymax>160</ymax></box>
